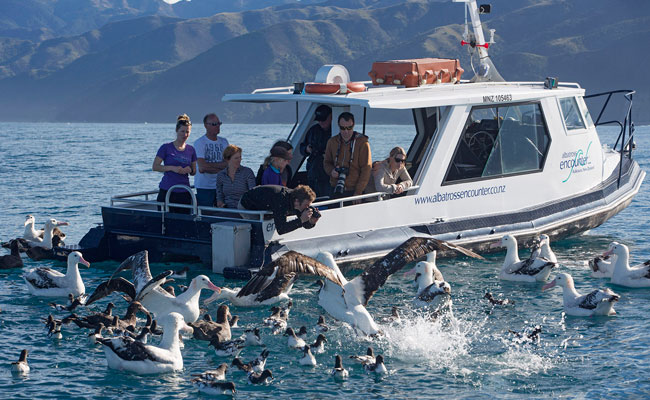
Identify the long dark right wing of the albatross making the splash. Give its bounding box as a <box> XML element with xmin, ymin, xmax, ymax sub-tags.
<box><xmin>351</xmin><ymin>237</ymin><xmax>483</xmax><ymax>306</ymax></box>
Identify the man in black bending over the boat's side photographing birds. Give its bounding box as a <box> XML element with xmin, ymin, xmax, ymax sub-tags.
<box><xmin>237</xmin><ymin>185</ymin><xmax>320</xmax><ymax>268</ymax></box>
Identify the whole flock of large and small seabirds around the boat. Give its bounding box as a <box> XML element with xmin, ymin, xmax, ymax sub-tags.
<box><xmin>0</xmin><ymin>215</ymin><xmax>650</xmax><ymax>395</ymax></box>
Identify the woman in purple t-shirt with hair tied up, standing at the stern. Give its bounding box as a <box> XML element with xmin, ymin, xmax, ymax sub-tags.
<box><xmin>152</xmin><ymin>114</ymin><xmax>196</xmax><ymax>214</ymax></box>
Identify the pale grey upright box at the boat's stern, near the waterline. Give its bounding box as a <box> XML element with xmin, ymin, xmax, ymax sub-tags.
<box><xmin>210</xmin><ymin>221</ymin><xmax>251</xmax><ymax>274</ymax></box>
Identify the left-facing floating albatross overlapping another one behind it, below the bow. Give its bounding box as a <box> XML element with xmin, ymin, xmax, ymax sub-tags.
<box><xmin>492</xmin><ymin>235</ymin><xmax>557</xmax><ymax>283</ymax></box>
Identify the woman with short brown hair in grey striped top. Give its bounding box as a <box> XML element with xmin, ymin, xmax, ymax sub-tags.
<box><xmin>217</xmin><ymin>144</ymin><xmax>255</xmax><ymax>208</ymax></box>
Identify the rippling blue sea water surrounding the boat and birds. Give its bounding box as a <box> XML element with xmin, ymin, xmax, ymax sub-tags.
<box><xmin>0</xmin><ymin>123</ymin><xmax>650</xmax><ymax>399</ymax></box>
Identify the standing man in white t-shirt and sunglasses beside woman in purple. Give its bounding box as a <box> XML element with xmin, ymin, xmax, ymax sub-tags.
<box><xmin>194</xmin><ymin>113</ymin><xmax>228</xmax><ymax>207</ymax></box>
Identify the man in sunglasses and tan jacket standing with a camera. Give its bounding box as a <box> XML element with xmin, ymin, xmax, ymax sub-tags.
<box><xmin>323</xmin><ymin>112</ymin><xmax>372</xmax><ymax>204</ymax></box>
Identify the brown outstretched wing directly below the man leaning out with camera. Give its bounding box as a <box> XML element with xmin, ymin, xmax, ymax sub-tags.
<box><xmin>237</xmin><ymin>251</ymin><xmax>342</xmax><ymax>302</ymax></box>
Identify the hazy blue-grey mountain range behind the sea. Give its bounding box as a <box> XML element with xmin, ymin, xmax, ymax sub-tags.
<box><xmin>0</xmin><ymin>0</ymin><xmax>650</xmax><ymax>123</ymax></box>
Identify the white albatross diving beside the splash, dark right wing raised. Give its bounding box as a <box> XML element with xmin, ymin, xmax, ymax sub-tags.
<box><xmin>316</xmin><ymin>237</ymin><xmax>483</xmax><ymax>335</ymax></box>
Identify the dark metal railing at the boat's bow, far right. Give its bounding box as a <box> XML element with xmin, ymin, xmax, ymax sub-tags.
<box><xmin>584</xmin><ymin>89</ymin><xmax>636</xmax><ymax>187</ymax></box>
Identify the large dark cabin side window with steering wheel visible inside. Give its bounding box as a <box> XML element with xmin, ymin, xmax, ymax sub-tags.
<box><xmin>443</xmin><ymin>103</ymin><xmax>550</xmax><ymax>184</ymax></box>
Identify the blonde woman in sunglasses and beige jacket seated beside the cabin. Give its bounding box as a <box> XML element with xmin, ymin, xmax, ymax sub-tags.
<box><xmin>365</xmin><ymin>146</ymin><xmax>413</xmax><ymax>200</ymax></box>
